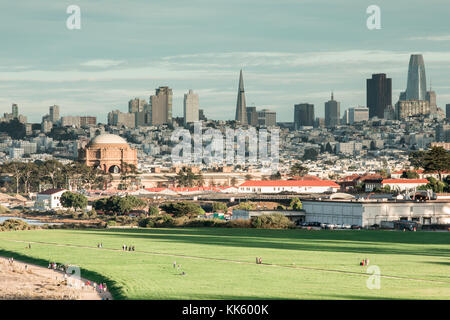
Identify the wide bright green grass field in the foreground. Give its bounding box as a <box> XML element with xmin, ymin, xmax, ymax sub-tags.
<box><xmin>0</xmin><ymin>228</ymin><xmax>450</xmax><ymax>299</ymax></box>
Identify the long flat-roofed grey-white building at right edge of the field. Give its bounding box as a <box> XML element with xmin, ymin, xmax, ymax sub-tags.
<box><xmin>302</xmin><ymin>200</ymin><xmax>450</xmax><ymax>227</ymax></box>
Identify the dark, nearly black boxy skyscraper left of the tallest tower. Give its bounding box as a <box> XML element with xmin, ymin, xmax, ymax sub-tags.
<box><xmin>367</xmin><ymin>73</ymin><xmax>392</xmax><ymax>119</ymax></box>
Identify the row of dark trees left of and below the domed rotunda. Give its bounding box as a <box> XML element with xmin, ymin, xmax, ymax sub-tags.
<box><xmin>0</xmin><ymin>160</ymin><xmax>112</xmax><ymax>193</ymax></box>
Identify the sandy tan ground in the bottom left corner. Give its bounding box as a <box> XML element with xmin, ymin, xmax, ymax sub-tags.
<box><xmin>0</xmin><ymin>257</ymin><xmax>112</xmax><ymax>300</ymax></box>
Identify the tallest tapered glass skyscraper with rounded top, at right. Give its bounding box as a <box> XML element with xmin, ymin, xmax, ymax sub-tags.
<box><xmin>401</xmin><ymin>54</ymin><xmax>427</xmax><ymax>100</ymax></box>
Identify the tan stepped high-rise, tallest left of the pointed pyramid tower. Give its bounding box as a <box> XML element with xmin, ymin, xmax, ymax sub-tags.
<box><xmin>150</xmin><ymin>87</ymin><xmax>173</xmax><ymax>125</ymax></box>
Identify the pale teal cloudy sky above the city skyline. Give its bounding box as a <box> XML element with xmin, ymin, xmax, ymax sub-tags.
<box><xmin>0</xmin><ymin>0</ymin><xmax>450</xmax><ymax>122</ymax></box>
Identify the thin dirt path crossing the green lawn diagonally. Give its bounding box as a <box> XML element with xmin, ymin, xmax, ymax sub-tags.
<box><xmin>4</xmin><ymin>239</ymin><xmax>450</xmax><ymax>285</ymax></box>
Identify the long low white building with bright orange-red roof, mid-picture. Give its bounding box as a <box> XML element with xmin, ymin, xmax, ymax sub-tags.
<box><xmin>238</xmin><ymin>180</ymin><xmax>339</xmax><ymax>194</ymax></box>
